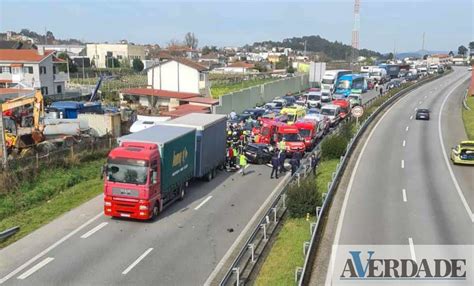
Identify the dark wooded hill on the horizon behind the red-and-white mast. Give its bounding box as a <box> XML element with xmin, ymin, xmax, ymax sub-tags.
<box><xmin>252</xmin><ymin>36</ymin><xmax>382</xmax><ymax>60</ymax></box>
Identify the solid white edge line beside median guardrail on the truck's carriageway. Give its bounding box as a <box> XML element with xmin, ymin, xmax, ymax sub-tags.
<box><xmin>204</xmin><ymin>172</ymin><xmax>290</xmax><ymax>286</ymax></box>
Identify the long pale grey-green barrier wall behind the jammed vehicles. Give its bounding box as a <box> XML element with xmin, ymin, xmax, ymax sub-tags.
<box><xmin>213</xmin><ymin>75</ymin><xmax>309</xmax><ymax>114</ymax></box>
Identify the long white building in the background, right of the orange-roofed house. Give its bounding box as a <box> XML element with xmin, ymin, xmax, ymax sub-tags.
<box><xmin>86</xmin><ymin>43</ymin><xmax>145</xmax><ymax>68</ymax></box>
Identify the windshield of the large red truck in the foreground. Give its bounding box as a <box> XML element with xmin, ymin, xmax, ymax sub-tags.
<box><xmin>107</xmin><ymin>159</ymin><xmax>148</xmax><ymax>185</ymax></box>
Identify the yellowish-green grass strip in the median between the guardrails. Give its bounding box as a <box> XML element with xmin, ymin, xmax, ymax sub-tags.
<box><xmin>255</xmin><ymin>159</ymin><xmax>339</xmax><ymax>286</ymax></box>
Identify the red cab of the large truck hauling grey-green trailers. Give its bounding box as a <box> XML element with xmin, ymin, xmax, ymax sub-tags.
<box><xmin>104</xmin><ymin>142</ymin><xmax>162</xmax><ymax>219</ymax></box>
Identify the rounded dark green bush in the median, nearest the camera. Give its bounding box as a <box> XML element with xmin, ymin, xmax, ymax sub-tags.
<box><xmin>287</xmin><ymin>176</ymin><xmax>322</xmax><ymax>217</ymax></box>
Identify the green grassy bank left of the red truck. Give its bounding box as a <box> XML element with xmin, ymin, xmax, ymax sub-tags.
<box><xmin>0</xmin><ymin>159</ymin><xmax>103</xmax><ymax>248</ymax></box>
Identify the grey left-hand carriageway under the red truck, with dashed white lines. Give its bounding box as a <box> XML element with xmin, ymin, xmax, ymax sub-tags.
<box><xmin>0</xmin><ymin>86</ymin><xmax>384</xmax><ymax>285</ymax></box>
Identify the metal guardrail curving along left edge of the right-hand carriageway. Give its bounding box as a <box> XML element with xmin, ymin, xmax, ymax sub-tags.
<box><xmin>295</xmin><ymin>73</ymin><xmax>446</xmax><ymax>286</ymax></box>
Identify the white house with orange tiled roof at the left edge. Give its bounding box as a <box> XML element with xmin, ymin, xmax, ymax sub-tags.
<box><xmin>0</xmin><ymin>49</ymin><xmax>69</xmax><ymax>95</ymax></box>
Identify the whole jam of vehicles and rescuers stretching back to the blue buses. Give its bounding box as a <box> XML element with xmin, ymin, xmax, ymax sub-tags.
<box><xmin>227</xmin><ymin>67</ymin><xmax>441</xmax><ymax>178</ymax></box>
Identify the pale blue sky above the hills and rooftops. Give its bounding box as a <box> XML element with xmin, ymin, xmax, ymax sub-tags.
<box><xmin>0</xmin><ymin>0</ymin><xmax>474</xmax><ymax>52</ymax></box>
